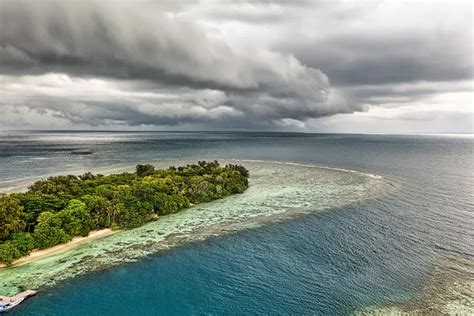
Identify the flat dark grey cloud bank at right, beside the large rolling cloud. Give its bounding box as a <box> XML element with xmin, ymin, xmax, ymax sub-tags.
<box><xmin>289</xmin><ymin>30</ymin><xmax>474</xmax><ymax>85</ymax></box>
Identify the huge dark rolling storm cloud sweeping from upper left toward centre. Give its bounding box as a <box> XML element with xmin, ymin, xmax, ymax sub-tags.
<box><xmin>0</xmin><ymin>1</ymin><xmax>352</xmax><ymax>125</ymax></box>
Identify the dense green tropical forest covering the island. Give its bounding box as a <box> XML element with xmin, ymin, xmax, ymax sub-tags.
<box><xmin>0</xmin><ymin>161</ymin><xmax>249</xmax><ymax>265</ymax></box>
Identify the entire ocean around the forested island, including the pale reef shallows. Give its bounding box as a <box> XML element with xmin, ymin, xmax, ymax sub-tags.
<box><xmin>0</xmin><ymin>131</ymin><xmax>474</xmax><ymax>315</ymax></box>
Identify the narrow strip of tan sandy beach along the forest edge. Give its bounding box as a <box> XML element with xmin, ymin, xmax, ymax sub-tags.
<box><xmin>0</xmin><ymin>228</ymin><xmax>117</xmax><ymax>268</ymax></box>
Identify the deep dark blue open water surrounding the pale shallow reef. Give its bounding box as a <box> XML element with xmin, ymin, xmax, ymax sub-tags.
<box><xmin>0</xmin><ymin>132</ymin><xmax>474</xmax><ymax>315</ymax></box>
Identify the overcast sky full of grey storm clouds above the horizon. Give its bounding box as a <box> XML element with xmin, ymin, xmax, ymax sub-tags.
<box><xmin>0</xmin><ymin>0</ymin><xmax>474</xmax><ymax>133</ymax></box>
